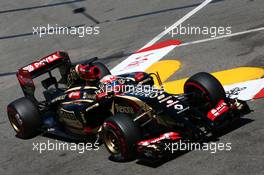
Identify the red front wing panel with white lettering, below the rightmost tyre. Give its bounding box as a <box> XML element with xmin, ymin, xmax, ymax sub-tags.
<box><xmin>207</xmin><ymin>100</ymin><xmax>229</xmax><ymax>121</ymax></box>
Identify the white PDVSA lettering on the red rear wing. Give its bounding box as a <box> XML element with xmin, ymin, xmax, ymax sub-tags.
<box><xmin>23</xmin><ymin>54</ymin><xmax>60</xmax><ymax>72</ymax></box>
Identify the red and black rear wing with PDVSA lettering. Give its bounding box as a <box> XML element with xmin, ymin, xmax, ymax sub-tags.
<box><xmin>16</xmin><ymin>51</ymin><xmax>71</xmax><ymax>99</ymax></box>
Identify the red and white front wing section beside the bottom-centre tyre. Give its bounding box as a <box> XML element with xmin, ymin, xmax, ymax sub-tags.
<box><xmin>137</xmin><ymin>132</ymin><xmax>181</xmax><ymax>146</ymax></box>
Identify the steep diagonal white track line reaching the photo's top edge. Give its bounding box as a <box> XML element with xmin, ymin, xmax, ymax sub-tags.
<box><xmin>141</xmin><ymin>0</ymin><xmax>213</xmax><ymax>49</ymax></box>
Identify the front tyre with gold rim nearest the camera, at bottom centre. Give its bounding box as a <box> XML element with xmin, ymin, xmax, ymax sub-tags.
<box><xmin>103</xmin><ymin>114</ymin><xmax>141</xmax><ymax>162</ymax></box>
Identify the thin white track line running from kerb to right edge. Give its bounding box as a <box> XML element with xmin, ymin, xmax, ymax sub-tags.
<box><xmin>176</xmin><ymin>27</ymin><xmax>264</xmax><ymax>47</ymax></box>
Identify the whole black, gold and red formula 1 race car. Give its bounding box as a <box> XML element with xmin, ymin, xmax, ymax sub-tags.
<box><xmin>7</xmin><ymin>52</ymin><xmax>250</xmax><ymax>161</ymax></box>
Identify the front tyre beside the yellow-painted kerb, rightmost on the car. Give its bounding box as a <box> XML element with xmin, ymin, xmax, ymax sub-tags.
<box><xmin>184</xmin><ymin>72</ymin><xmax>226</xmax><ymax>107</ymax></box>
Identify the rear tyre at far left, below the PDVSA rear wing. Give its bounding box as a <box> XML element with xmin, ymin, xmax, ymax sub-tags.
<box><xmin>7</xmin><ymin>97</ymin><xmax>42</xmax><ymax>139</ymax></box>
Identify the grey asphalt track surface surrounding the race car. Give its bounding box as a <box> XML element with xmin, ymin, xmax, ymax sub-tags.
<box><xmin>0</xmin><ymin>0</ymin><xmax>264</xmax><ymax>175</ymax></box>
